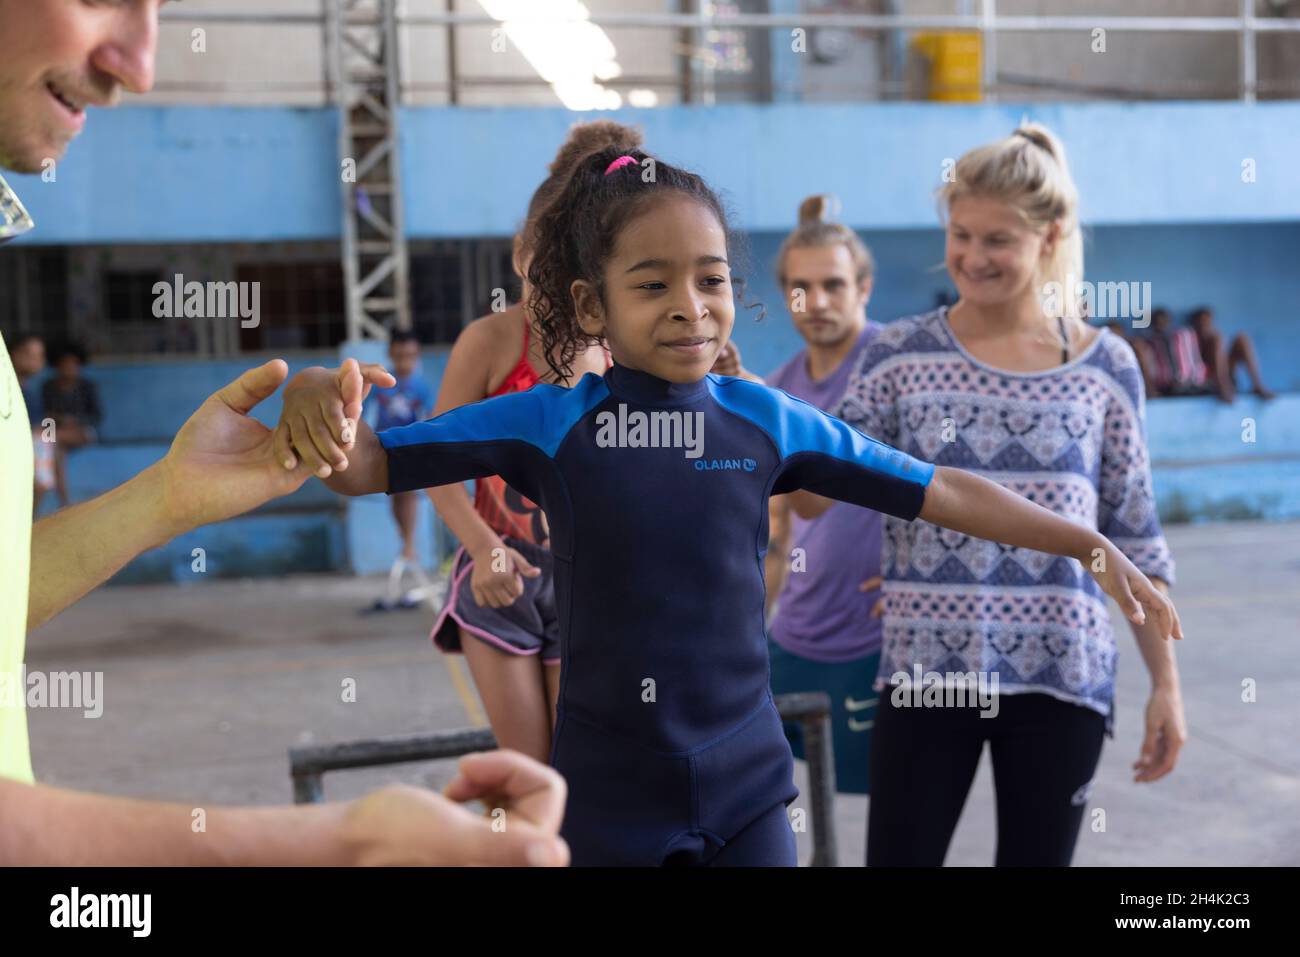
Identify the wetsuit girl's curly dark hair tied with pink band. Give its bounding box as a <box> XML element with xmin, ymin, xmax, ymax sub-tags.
<box><xmin>528</xmin><ymin>147</ymin><xmax>763</xmax><ymax>381</ymax></box>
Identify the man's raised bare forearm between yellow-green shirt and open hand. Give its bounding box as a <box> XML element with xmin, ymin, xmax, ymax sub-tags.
<box><xmin>27</xmin><ymin>464</ymin><xmax>182</xmax><ymax>631</ymax></box>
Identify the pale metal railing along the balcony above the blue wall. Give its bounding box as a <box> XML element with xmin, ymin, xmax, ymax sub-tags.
<box><xmin>163</xmin><ymin>0</ymin><xmax>1300</xmax><ymax>103</ymax></box>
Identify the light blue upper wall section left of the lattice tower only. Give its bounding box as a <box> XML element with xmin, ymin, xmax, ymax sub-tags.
<box><xmin>10</xmin><ymin>107</ymin><xmax>342</xmax><ymax>243</ymax></box>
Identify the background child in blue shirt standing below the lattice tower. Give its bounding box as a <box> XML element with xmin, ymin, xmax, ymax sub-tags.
<box><xmin>371</xmin><ymin>330</ymin><xmax>433</xmax><ymax>607</ymax></box>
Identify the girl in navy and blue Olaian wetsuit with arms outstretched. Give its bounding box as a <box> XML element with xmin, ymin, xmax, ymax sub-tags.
<box><xmin>277</xmin><ymin>150</ymin><xmax>1180</xmax><ymax>866</ymax></box>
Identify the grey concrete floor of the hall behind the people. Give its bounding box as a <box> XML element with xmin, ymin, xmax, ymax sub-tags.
<box><xmin>27</xmin><ymin>523</ymin><xmax>1300</xmax><ymax>866</ymax></box>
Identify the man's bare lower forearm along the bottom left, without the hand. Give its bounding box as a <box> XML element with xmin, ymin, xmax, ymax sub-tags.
<box><xmin>0</xmin><ymin>779</ymin><xmax>351</xmax><ymax>867</ymax></box>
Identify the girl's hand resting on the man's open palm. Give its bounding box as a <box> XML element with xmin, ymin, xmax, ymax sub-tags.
<box><xmin>274</xmin><ymin>359</ymin><xmax>397</xmax><ymax>479</ymax></box>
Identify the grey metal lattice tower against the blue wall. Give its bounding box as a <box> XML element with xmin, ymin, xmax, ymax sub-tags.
<box><xmin>325</xmin><ymin>0</ymin><xmax>411</xmax><ymax>339</ymax></box>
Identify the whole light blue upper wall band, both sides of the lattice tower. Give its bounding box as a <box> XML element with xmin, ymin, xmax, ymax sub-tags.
<box><xmin>14</xmin><ymin>103</ymin><xmax>1300</xmax><ymax>243</ymax></box>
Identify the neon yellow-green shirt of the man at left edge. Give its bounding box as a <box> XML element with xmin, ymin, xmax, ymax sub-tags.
<box><xmin>0</xmin><ymin>335</ymin><xmax>33</xmax><ymax>783</ymax></box>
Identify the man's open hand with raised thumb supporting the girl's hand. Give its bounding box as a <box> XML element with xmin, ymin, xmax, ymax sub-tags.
<box><xmin>156</xmin><ymin>359</ymin><xmax>311</xmax><ymax>537</ymax></box>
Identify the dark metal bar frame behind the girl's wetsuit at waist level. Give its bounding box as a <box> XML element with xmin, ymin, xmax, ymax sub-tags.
<box><xmin>289</xmin><ymin>692</ymin><xmax>839</xmax><ymax>867</ymax></box>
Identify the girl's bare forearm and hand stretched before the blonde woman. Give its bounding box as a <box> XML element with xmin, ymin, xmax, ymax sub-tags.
<box><xmin>918</xmin><ymin>465</ymin><xmax>1183</xmax><ymax>638</ymax></box>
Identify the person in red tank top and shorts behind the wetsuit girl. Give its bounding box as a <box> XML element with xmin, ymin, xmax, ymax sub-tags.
<box><xmin>428</xmin><ymin>120</ymin><xmax>629</xmax><ymax>762</ymax></box>
